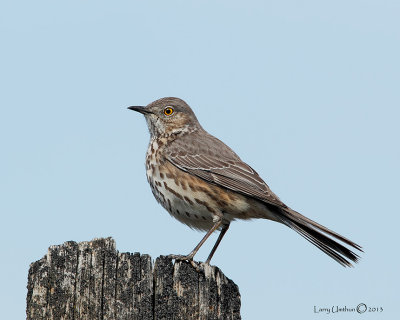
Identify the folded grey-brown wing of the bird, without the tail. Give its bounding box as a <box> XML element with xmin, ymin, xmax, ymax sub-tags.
<box><xmin>166</xmin><ymin>131</ymin><xmax>287</xmax><ymax>208</ymax></box>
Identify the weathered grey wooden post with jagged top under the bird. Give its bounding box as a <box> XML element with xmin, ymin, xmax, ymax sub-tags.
<box><xmin>26</xmin><ymin>238</ymin><xmax>240</xmax><ymax>320</ymax></box>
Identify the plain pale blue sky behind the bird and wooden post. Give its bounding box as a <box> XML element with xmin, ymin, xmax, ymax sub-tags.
<box><xmin>0</xmin><ymin>0</ymin><xmax>400</xmax><ymax>320</ymax></box>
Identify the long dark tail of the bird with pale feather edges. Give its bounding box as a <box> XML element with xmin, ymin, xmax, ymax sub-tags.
<box><xmin>276</xmin><ymin>208</ymin><xmax>363</xmax><ymax>267</ymax></box>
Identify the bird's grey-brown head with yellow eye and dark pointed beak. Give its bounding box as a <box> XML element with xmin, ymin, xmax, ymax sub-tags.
<box><xmin>128</xmin><ymin>97</ymin><xmax>201</xmax><ymax>137</ymax></box>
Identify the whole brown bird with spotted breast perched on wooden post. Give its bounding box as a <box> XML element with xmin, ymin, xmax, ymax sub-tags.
<box><xmin>128</xmin><ymin>97</ymin><xmax>363</xmax><ymax>267</ymax></box>
